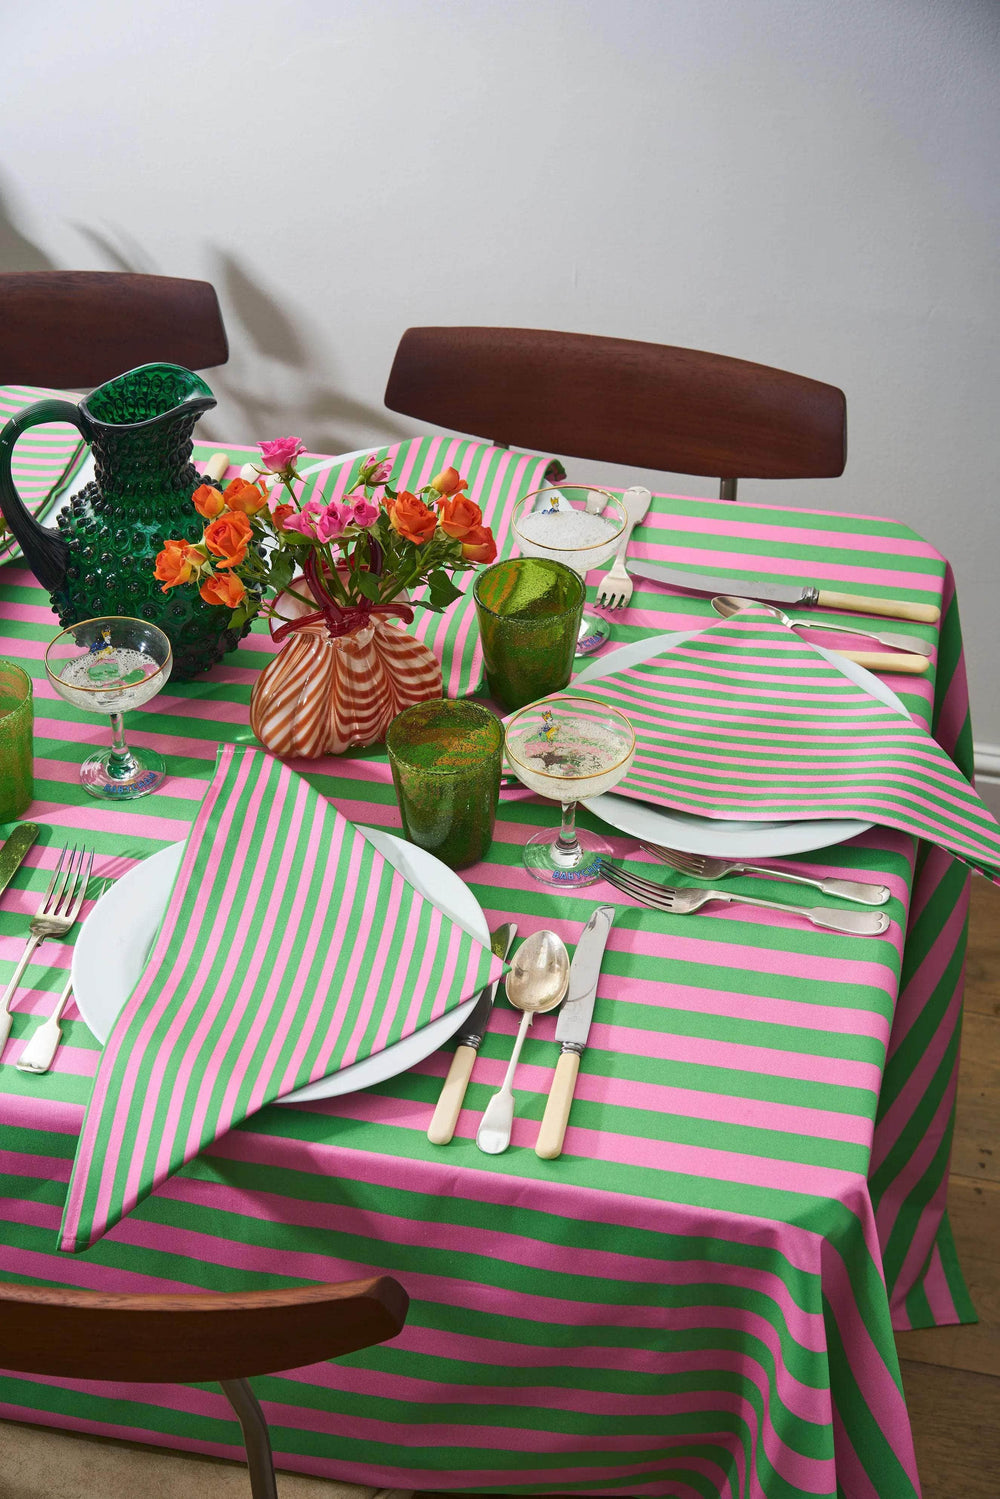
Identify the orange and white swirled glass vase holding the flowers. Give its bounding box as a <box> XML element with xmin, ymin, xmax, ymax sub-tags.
<box><xmin>250</xmin><ymin>580</ymin><xmax>444</xmax><ymax>760</ymax></box>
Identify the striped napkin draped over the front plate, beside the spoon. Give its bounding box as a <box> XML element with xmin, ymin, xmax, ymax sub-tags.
<box><xmin>58</xmin><ymin>745</ymin><xmax>507</xmax><ymax>1252</ymax></box>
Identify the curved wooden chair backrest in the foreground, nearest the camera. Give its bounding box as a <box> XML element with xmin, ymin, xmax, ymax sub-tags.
<box><xmin>0</xmin><ymin>1276</ymin><xmax>409</xmax><ymax>1384</ymax></box>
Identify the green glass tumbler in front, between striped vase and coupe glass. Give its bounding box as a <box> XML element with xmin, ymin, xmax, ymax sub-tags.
<box><xmin>385</xmin><ymin>697</ymin><xmax>504</xmax><ymax>869</ymax></box>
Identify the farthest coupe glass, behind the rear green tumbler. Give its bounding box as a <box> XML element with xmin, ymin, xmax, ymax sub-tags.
<box><xmin>511</xmin><ymin>484</ymin><xmax>628</xmax><ymax>655</ymax></box>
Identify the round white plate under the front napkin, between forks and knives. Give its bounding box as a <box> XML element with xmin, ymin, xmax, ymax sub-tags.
<box><xmin>72</xmin><ymin>827</ymin><xmax>490</xmax><ymax>1103</ymax></box>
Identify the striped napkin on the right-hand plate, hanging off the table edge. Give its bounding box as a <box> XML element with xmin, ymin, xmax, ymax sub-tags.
<box><xmin>573</xmin><ymin>609</ymin><xmax>1000</xmax><ymax>883</ymax></box>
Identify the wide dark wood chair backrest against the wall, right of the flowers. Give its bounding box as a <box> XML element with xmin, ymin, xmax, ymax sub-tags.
<box><xmin>385</xmin><ymin>328</ymin><xmax>847</xmax><ymax>480</ymax></box>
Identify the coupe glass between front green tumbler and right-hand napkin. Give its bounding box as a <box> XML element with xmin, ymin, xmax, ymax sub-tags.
<box><xmin>504</xmin><ymin>693</ymin><xmax>636</xmax><ymax>886</ymax></box>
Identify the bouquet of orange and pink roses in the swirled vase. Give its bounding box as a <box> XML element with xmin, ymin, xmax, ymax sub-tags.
<box><xmin>156</xmin><ymin>438</ymin><xmax>496</xmax><ymax>640</ymax></box>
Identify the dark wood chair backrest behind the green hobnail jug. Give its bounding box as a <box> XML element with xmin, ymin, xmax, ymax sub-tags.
<box><xmin>0</xmin><ymin>271</ymin><xmax>229</xmax><ymax>390</ymax></box>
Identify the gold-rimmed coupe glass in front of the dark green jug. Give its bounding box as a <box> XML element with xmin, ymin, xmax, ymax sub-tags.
<box><xmin>45</xmin><ymin>615</ymin><xmax>174</xmax><ymax>802</ymax></box>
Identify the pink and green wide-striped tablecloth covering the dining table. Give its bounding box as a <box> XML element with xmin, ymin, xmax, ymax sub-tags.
<box><xmin>0</xmin><ymin>428</ymin><xmax>975</xmax><ymax>1499</ymax></box>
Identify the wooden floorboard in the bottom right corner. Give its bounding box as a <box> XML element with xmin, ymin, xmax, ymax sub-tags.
<box><xmin>903</xmin><ymin>1363</ymin><xmax>1000</xmax><ymax>1499</ymax></box>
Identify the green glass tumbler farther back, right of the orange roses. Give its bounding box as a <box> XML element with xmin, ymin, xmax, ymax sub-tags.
<box><xmin>472</xmin><ymin>558</ymin><xmax>586</xmax><ymax>712</ymax></box>
